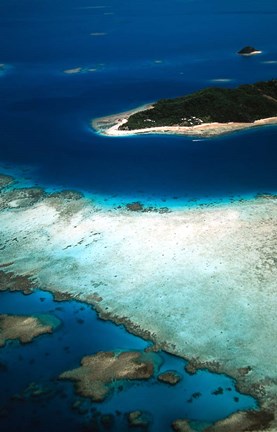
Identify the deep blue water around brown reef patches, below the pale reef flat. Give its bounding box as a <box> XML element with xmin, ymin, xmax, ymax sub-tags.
<box><xmin>0</xmin><ymin>291</ymin><xmax>256</xmax><ymax>432</ymax></box>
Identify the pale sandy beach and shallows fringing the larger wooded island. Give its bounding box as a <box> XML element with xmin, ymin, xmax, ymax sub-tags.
<box><xmin>91</xmin><ymin>104</ymin><xmax>277</xmax><ymax>138</ymax></box>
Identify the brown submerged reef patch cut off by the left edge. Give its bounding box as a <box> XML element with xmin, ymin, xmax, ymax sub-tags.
<box><xmin>0</xmin><ymin>314</ymin><xmax>59</xmax><ymax>348</ymax></box>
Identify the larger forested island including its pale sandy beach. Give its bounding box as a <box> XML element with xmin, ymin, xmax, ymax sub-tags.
<box><xmin>92</xmin><ymin>79</ymin><xmax>277</xmax><ymax>137</ymax></box>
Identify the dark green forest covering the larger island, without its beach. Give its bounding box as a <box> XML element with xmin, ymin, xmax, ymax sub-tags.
<box><xmin>120</xmin><ymin>79</ymin><xmax>277</xmax><ymax>130</ymax></box>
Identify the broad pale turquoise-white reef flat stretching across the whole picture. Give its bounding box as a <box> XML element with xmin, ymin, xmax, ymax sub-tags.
<box><xmin>0</xmin><ymin>175</ymin><xmax>277</xmax><ymax>432</ymax></box>
